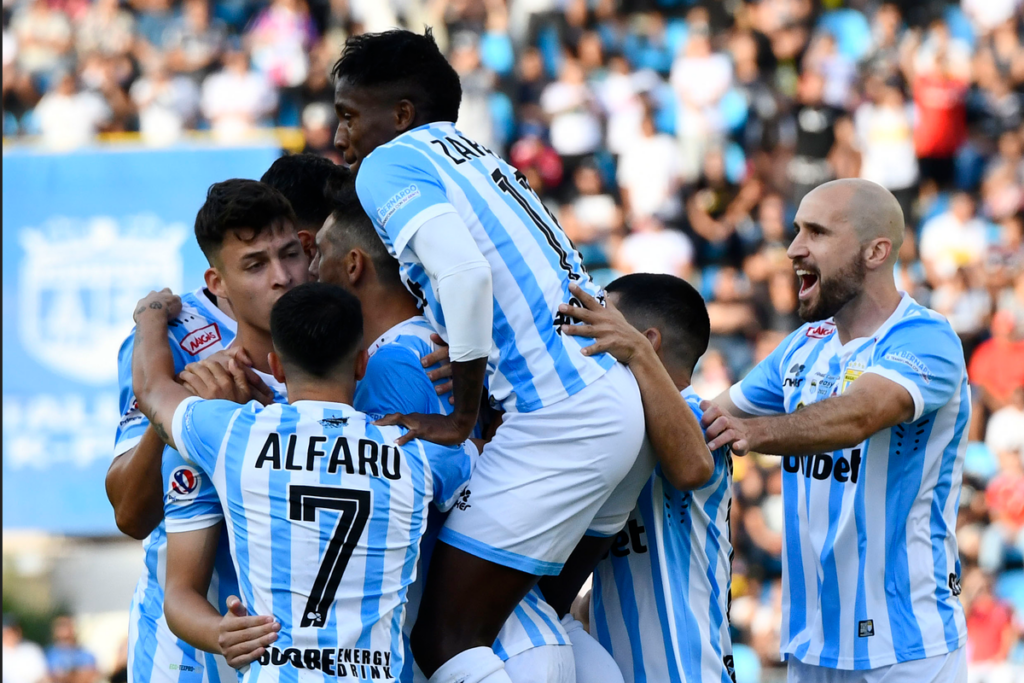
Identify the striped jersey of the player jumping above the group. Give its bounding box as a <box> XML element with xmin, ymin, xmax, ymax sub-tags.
<box><xmin>355</xmin><ymin>123</ymin><xmax>614</xmax><ymax>413</ymax></box>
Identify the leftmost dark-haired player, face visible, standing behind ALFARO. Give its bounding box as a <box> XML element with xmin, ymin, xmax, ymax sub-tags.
<box><xmin>108</xmin><ymin>179</ymin><xmax>308</xmax><ymax>683</ymax></box>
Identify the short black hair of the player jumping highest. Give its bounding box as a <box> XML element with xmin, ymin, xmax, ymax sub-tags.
<box><xmin>331</xmin><ymin>29</ymin><xmax>462</xmax><ymax>123</ymax></box>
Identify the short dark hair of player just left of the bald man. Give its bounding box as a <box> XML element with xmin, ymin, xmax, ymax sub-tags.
<box><xmin>604</xmin><ymin>272</ymin><xmax>711</xmax><ymax>373</ymax></box>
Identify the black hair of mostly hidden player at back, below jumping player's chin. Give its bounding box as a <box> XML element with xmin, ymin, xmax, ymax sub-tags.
<box><xmin>260</xmin><ymin>154</ymin><xmax>351</xmax><ymax>231</ymax></box>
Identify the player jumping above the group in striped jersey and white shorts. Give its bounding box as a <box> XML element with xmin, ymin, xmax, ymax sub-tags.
<box><xmin>334</xmin><ymin>26</ymin><xmax>702</xmax><ymax>683</ymax></box>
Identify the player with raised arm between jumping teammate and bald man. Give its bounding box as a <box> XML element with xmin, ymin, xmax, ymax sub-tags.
<box><xmin>566</xmin><ymin>273</ymin><xmax>732</xmax><ymax>683</ymax></box>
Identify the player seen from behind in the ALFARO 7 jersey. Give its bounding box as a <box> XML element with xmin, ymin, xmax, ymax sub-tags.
<box><xmin>132</xmin><ymin>284</ymin><xmax>473</xmax><ymax>681</ymax></box>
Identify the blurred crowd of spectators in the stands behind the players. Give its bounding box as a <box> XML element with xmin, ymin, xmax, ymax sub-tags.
<box><xmin>3</xmin><ymin>0</ymin><xmax>1024</xmax><ymax>683</ymax></box>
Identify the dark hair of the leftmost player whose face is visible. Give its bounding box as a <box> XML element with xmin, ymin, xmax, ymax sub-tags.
<box><xmin>196</xmin><ymin>178</ymin><xmax>297</xmax><ymax>264</ymax></box>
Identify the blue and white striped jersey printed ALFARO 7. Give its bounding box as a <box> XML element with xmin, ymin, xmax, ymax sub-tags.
<box><xmin>173</xmin><ymin>398</ymin><xmax>472</xmax><ymax>682</ymax></box>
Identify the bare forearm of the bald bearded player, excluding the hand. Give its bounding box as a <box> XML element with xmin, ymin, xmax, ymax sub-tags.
<box><xmin>748</xmin><ymin>396</ymin><xmax>891</xmax><ymax>456</ymax></box>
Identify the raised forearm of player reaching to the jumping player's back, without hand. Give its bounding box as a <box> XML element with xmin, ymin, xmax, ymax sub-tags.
<box><xmin>630</xmin><ymin>344</ymin><xmax>715</xmax><ymax>490</ymax></box>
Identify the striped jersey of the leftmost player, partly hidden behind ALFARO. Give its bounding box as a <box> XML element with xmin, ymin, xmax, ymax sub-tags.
<box><xmin>114</xmin><ymin>289</ymin><xmax>238</xmax><ymax>683</ymax></box>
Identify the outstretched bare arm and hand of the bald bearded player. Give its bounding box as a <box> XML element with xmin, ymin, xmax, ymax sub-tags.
<box><xmin>701</xmin><ymin>374</ymin><xmax>914</xmax><ymax>456</ymax></box>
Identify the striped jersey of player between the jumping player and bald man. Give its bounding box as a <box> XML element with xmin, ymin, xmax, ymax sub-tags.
<box><xmin>590</xmin><ymin>387</ymin><xmax>735</xmax><ymax>683</ymax></box>
